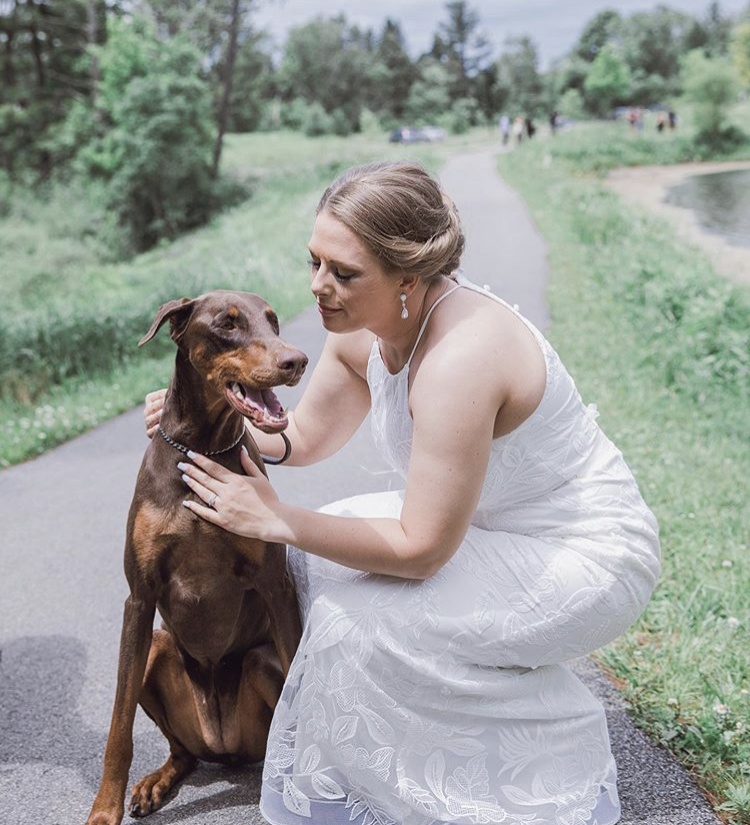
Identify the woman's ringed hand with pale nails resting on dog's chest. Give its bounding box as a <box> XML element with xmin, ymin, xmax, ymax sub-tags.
<box><xmin>177</xmin><ymin>447</ymin><xmax>279</xmax><ymax>541</ymax></box>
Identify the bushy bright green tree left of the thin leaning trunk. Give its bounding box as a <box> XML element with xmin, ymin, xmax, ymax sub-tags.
<box><xmin>76</xmin><ymin>17</ymin><xmax>215</xmax><ymax>250</ymax></box>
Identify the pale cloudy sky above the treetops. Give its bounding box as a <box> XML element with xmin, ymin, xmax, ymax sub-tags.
<box><xmin>254</xmin><ymin>0</ymin><xmax>750</xmax><ymax>70</ymax></box>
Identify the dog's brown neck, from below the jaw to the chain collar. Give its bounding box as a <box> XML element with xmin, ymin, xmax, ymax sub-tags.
<box><xmin>161</xmin><ymin>350</ymin><xmax>245</xmax><ymax>454</ymax></box>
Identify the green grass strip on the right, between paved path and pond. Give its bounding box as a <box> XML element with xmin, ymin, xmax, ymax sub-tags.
<box><xmin>501</xmin><ymin>112</ymin><xmax>750</xmax><ymax>825</ymax></box>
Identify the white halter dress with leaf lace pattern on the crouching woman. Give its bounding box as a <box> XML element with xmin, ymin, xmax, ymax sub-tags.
<box><xmin>261</xmin><ymin>278</ymin><xmax>659</xmax><ymax>825</ymax></box>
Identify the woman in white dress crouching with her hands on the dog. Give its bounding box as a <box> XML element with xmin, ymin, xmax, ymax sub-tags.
<box><xmin>147</xmin><ymin>163</ymin><xmax>659</xmax><ymax>825</ymax></box>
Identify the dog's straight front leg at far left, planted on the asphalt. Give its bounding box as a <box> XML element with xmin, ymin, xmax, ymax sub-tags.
<box><xmin>86</xmin><ymin>592</ymin><xmax>156</xmax><ymax>825</ymax></box>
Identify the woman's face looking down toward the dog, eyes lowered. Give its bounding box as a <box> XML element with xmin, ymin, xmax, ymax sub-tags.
<box><xmin>308</xmin><ymin>210</ymin><xmax>401</xmax><ymax>337</ymax></box>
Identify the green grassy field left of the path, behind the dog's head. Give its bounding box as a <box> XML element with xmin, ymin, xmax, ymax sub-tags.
<box><xmin>0</xmin><ymin>125</ymin><xmax>502</xmax><ymax>467</ymax></box>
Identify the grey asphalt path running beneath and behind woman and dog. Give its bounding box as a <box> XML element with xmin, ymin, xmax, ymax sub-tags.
<box><xmin>0</xmin><ymin>151</ymin><xmax>718</xmax><ymax>825</ymax></box>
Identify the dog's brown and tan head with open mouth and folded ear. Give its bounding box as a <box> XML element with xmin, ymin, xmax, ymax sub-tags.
<box><xmin>138</xmin><ymin>290</ymin><xmax>307</xmax><ymax>433</ymax></box>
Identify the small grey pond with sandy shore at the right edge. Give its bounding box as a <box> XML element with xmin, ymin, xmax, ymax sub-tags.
<box><xmin>665</xmin><ymin>169</ymin><xmax>750</xmax><ymax>247</ymax></box>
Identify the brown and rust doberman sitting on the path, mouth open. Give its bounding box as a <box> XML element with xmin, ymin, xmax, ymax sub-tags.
<box><xmin>87</xmin><ymin>290</ymin><xmax>307</xmax><ymax>825</ymax></box>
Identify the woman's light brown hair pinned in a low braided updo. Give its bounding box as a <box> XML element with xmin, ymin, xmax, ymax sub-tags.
<box><xmin>316</xmin><ymin>162</ymin><xmax>464</xmax><ymax>280</ymax></box>
